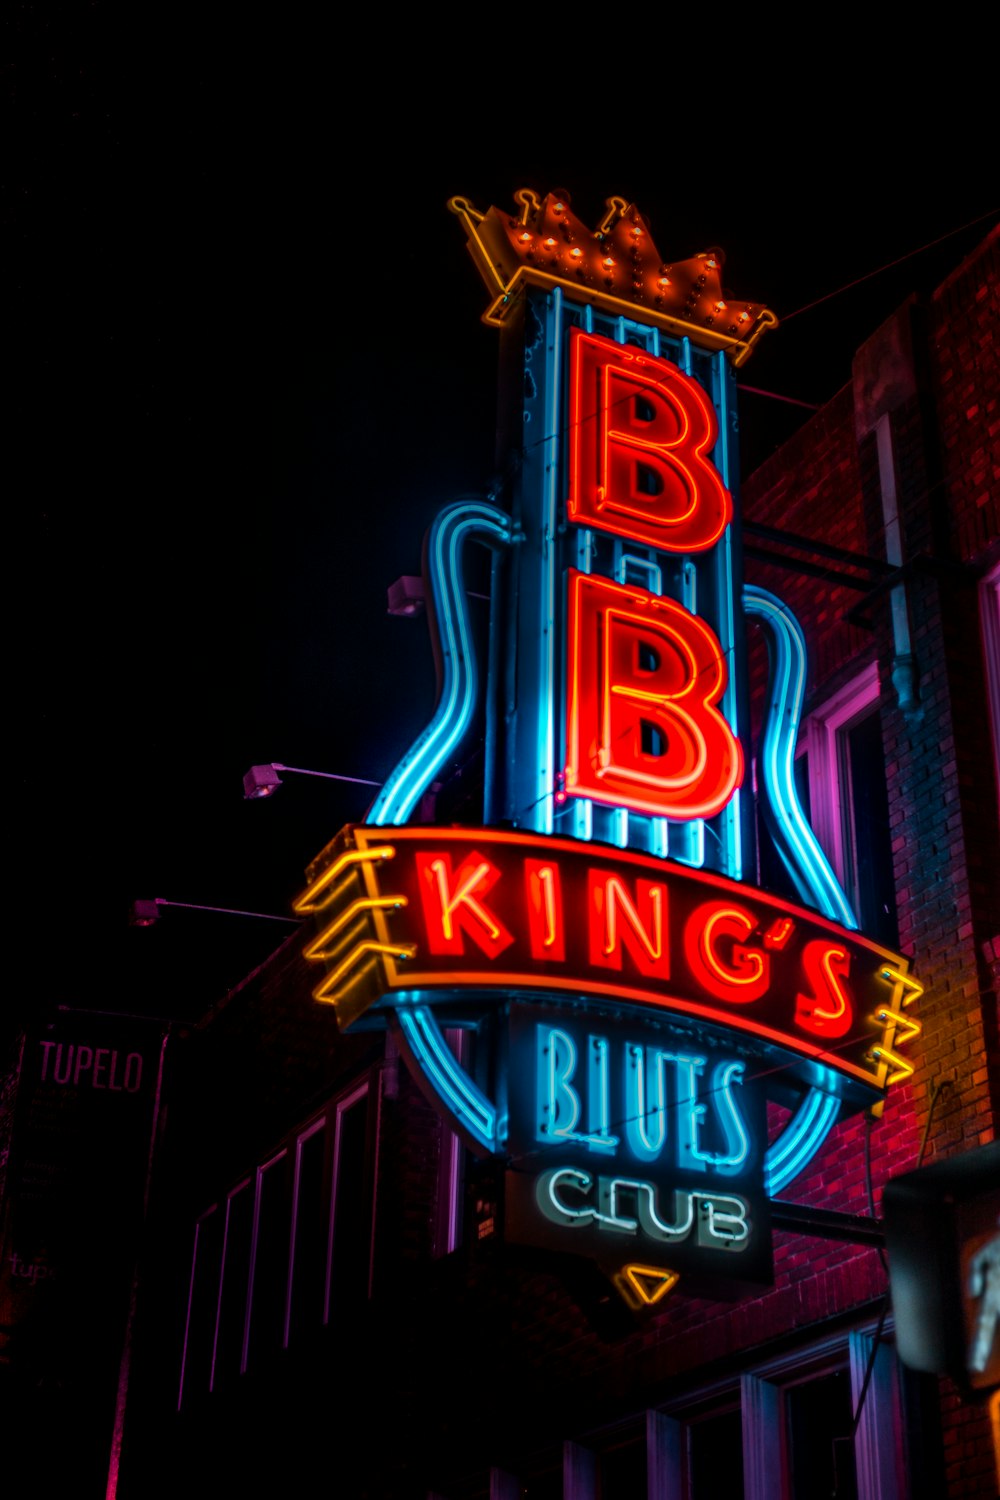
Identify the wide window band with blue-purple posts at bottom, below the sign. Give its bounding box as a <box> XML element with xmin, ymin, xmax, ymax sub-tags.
<box><xmin>428</xmin><ymin>1317</ymin><xmax>943</xmax><ymax>1500</ymax></box>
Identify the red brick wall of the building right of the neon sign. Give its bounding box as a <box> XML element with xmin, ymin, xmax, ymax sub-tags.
<box><xmin>732</xmin><ymin>231</ymin><xmax>1000</xmax><ymax>1496</ymax></box>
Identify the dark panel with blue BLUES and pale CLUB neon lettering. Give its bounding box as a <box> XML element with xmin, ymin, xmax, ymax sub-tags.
<box><xmin>505</xmin><ymin>1001</ymin><xmax>771</xmax><ymax>1290</ymax></box>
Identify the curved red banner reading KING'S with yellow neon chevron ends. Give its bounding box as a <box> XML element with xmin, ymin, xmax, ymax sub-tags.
<box><xmin>300</xmin><ymin>825</ymin><xmax>921</xmax><ymax>1095</ymax></box>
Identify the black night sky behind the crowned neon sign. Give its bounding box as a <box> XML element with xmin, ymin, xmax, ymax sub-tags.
<box><xmin>4</xmin><ymin>14</ymin><xmax>1000</xmax><ymax>1044</ymax></box>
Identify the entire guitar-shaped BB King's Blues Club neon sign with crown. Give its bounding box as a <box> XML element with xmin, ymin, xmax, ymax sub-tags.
<box><xmin>297</xmin><ymin>191</ymin><xmax>921</xmax><ymax>1307</ymax></box>
